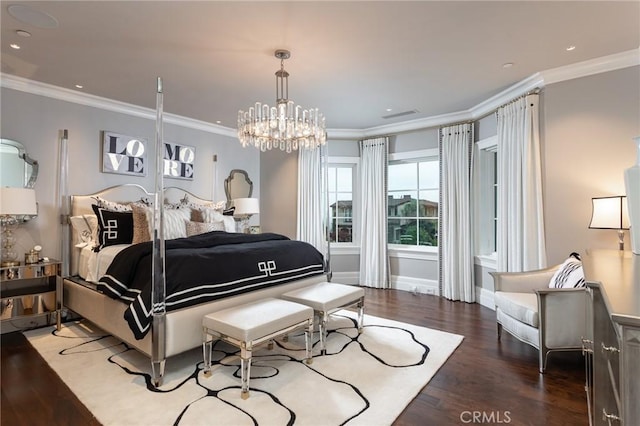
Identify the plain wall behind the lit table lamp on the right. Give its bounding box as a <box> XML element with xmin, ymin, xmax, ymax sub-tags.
<box><xmin>542</xmin><ymin>66</ymin><xmax>640</xmax><ymax>264</ymax></box>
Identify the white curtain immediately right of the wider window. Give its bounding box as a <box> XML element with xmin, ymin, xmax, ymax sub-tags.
<box><xmin>438</xmin><ymin>123</ymin><xmax>475</xmax><ymax>303</ymax></box>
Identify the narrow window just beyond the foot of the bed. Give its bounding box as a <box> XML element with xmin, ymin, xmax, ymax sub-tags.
<box><xmin>327</xmin><ymin>158</ymin><xmax>357</xmax><ymax>243</ymax></box>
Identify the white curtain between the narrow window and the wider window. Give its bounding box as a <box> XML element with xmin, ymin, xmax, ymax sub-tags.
<box><xmin>360</xmin><ymin>138</ymin><xmax>389</xmax><ymax>288</ymax></box>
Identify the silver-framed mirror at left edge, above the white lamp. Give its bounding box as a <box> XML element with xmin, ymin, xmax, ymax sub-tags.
<box><xmin>0</xmin><ymin>139</ymin><xmax>38</xmax><ymax>188</ymax></box>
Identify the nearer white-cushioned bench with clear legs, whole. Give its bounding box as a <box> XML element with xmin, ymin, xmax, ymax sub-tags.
<box><xmin>202</xmin><ymin>298</ymin><xmax>314</xmax><ymax>399</ymax></box>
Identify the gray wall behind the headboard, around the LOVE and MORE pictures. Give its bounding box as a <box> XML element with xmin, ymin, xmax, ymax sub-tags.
<box><xmin>0</xmin><ymin>88</ymin><xmax>260</xmax><ymax>258</ymax></box>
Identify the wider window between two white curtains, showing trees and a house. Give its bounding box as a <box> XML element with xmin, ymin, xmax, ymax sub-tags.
<box><xmin>387</xmin><ymin>150</ymin><xmax>440</xmax><ymax>247</ymax></box>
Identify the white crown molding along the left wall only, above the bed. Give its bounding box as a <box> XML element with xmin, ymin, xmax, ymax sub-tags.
<box><xmin>0</xmin><ymin>73</ymin><xmax>237</xmax><ymax>138</ymax></box>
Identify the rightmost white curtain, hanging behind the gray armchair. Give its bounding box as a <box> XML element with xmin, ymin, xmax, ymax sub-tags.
<box><xmin>496</xmin><ymin>94</ymin><xmax>547</xmax><ymax>272</ymax></box>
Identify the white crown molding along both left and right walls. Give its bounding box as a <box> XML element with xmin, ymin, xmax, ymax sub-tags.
<box><xmin>0</xmin><ymin>47</ymin><xmax>640</xmax><ymax>140</ymax></box>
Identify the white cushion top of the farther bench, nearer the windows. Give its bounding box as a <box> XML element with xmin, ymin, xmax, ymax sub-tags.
<box><xmin>282</xmin><ymin>282</ymin><xmax>364</xmax><ymax>312</ymax></box>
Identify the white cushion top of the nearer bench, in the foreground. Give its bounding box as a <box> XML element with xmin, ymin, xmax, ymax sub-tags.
<box><xmin>202</xmin><ymin>298</ymin><xmax>313</xmax><ymax>342</ymax></box>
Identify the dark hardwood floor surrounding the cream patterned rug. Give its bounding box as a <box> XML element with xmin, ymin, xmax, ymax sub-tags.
<box><xmin>0</xmin><ymin>289</ymin><xmax>588</xmax><ymax>426</ymax></box>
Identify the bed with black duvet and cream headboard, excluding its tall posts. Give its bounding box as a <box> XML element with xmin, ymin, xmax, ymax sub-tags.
<box><xmin>63</xmin><ymin>184</ymin><xmax>326</xmax><ymax>385</ymax></box>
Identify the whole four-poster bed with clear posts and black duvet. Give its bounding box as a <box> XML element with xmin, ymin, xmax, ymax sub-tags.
<box><xmin>58</xmin><ymin>78</ymin><xmax>331</xmax><ymax>386</ymax></box>
